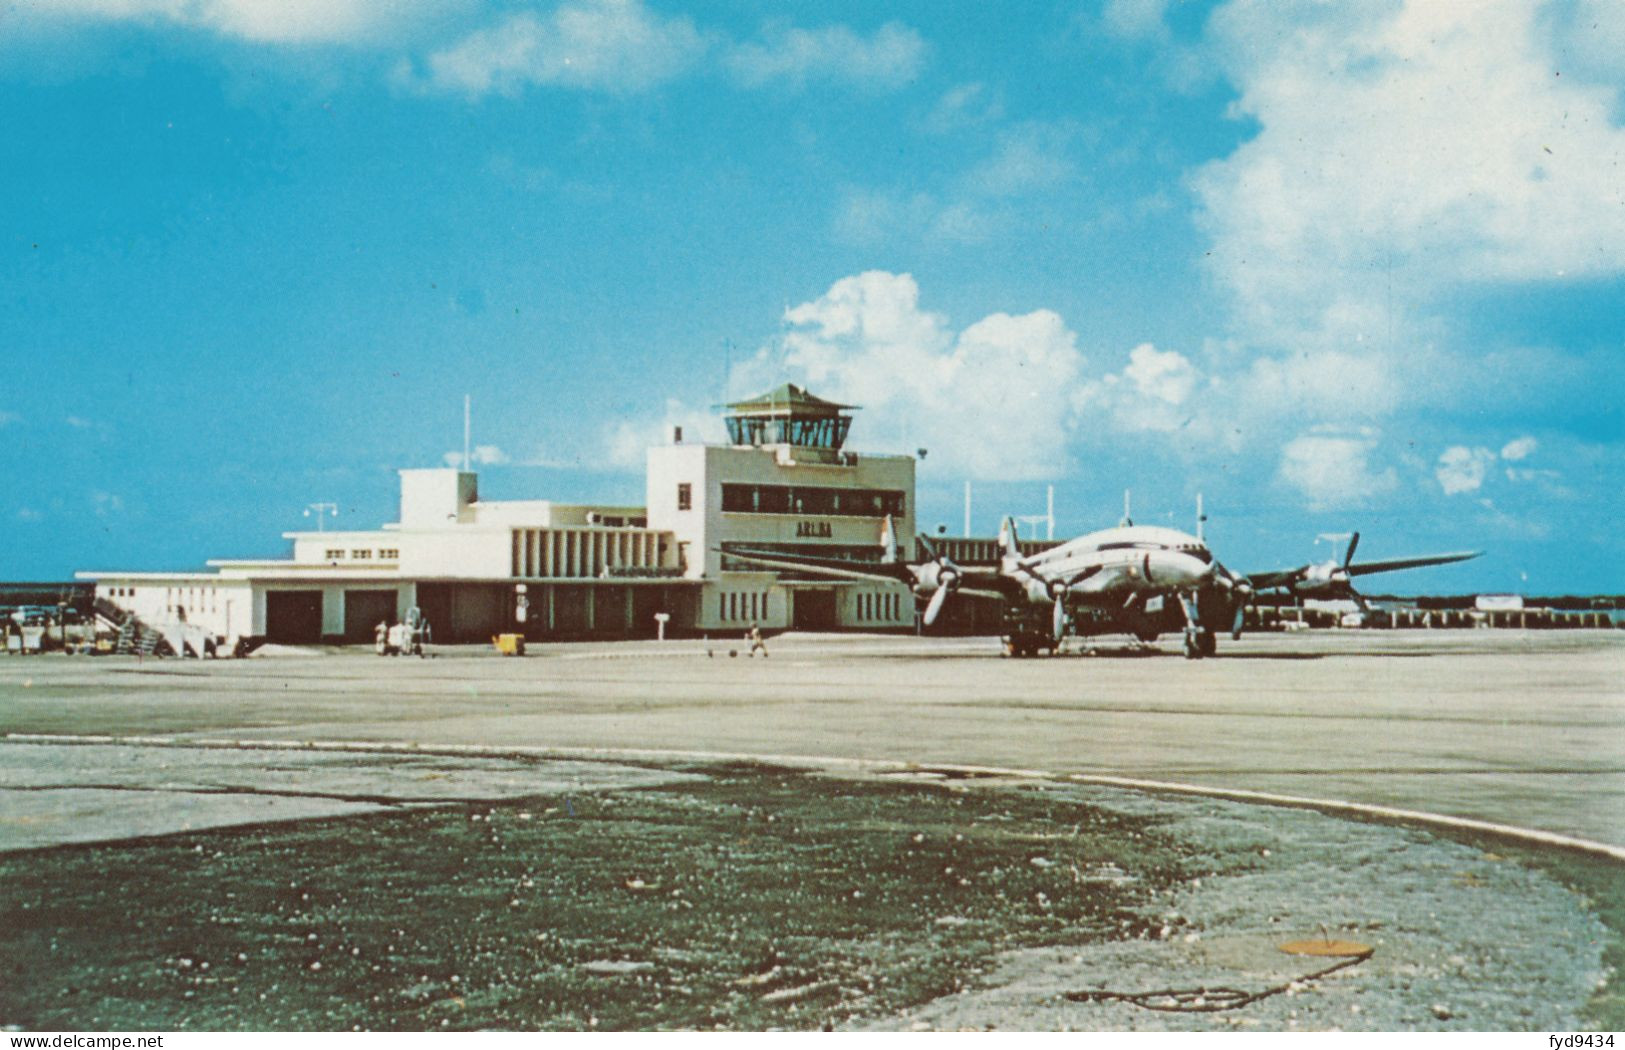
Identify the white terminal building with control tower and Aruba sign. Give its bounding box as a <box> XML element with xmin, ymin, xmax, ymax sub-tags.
<box><xmin>78</xmin><ymin>384</ymin><xmax>915</xmax><ymax>645</ymax></box>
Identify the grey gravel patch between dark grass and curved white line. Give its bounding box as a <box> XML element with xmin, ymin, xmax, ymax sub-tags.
<box><xmin>871</xmin><ymin>788</ymin><xmax>1610</xmax><ymax>1030</ymax></box>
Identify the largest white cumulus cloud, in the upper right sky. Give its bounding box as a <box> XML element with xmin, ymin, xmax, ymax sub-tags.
<box><xmin>1193</xmin><ymin>0</ymin><xmax>1625</xmax><ymax>340</ymax></box>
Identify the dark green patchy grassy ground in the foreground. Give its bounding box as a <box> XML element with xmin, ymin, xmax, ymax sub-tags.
<box><xmin>0</xmin><ymin>767</ymin><xmax>1183</xmax><ymax>1030</ymax></box>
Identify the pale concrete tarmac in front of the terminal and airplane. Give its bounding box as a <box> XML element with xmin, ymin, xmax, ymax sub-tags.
<box><xmin>0</xmin><ymin>631</ymin><xmax>1625</xmax><ymax>848</ymax></box>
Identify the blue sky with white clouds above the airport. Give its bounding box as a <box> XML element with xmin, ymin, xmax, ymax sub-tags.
<box><xmin>0</xmin><ymin>0</ymin><xmax>1625</xmax><ymax>593</ymax></box>
